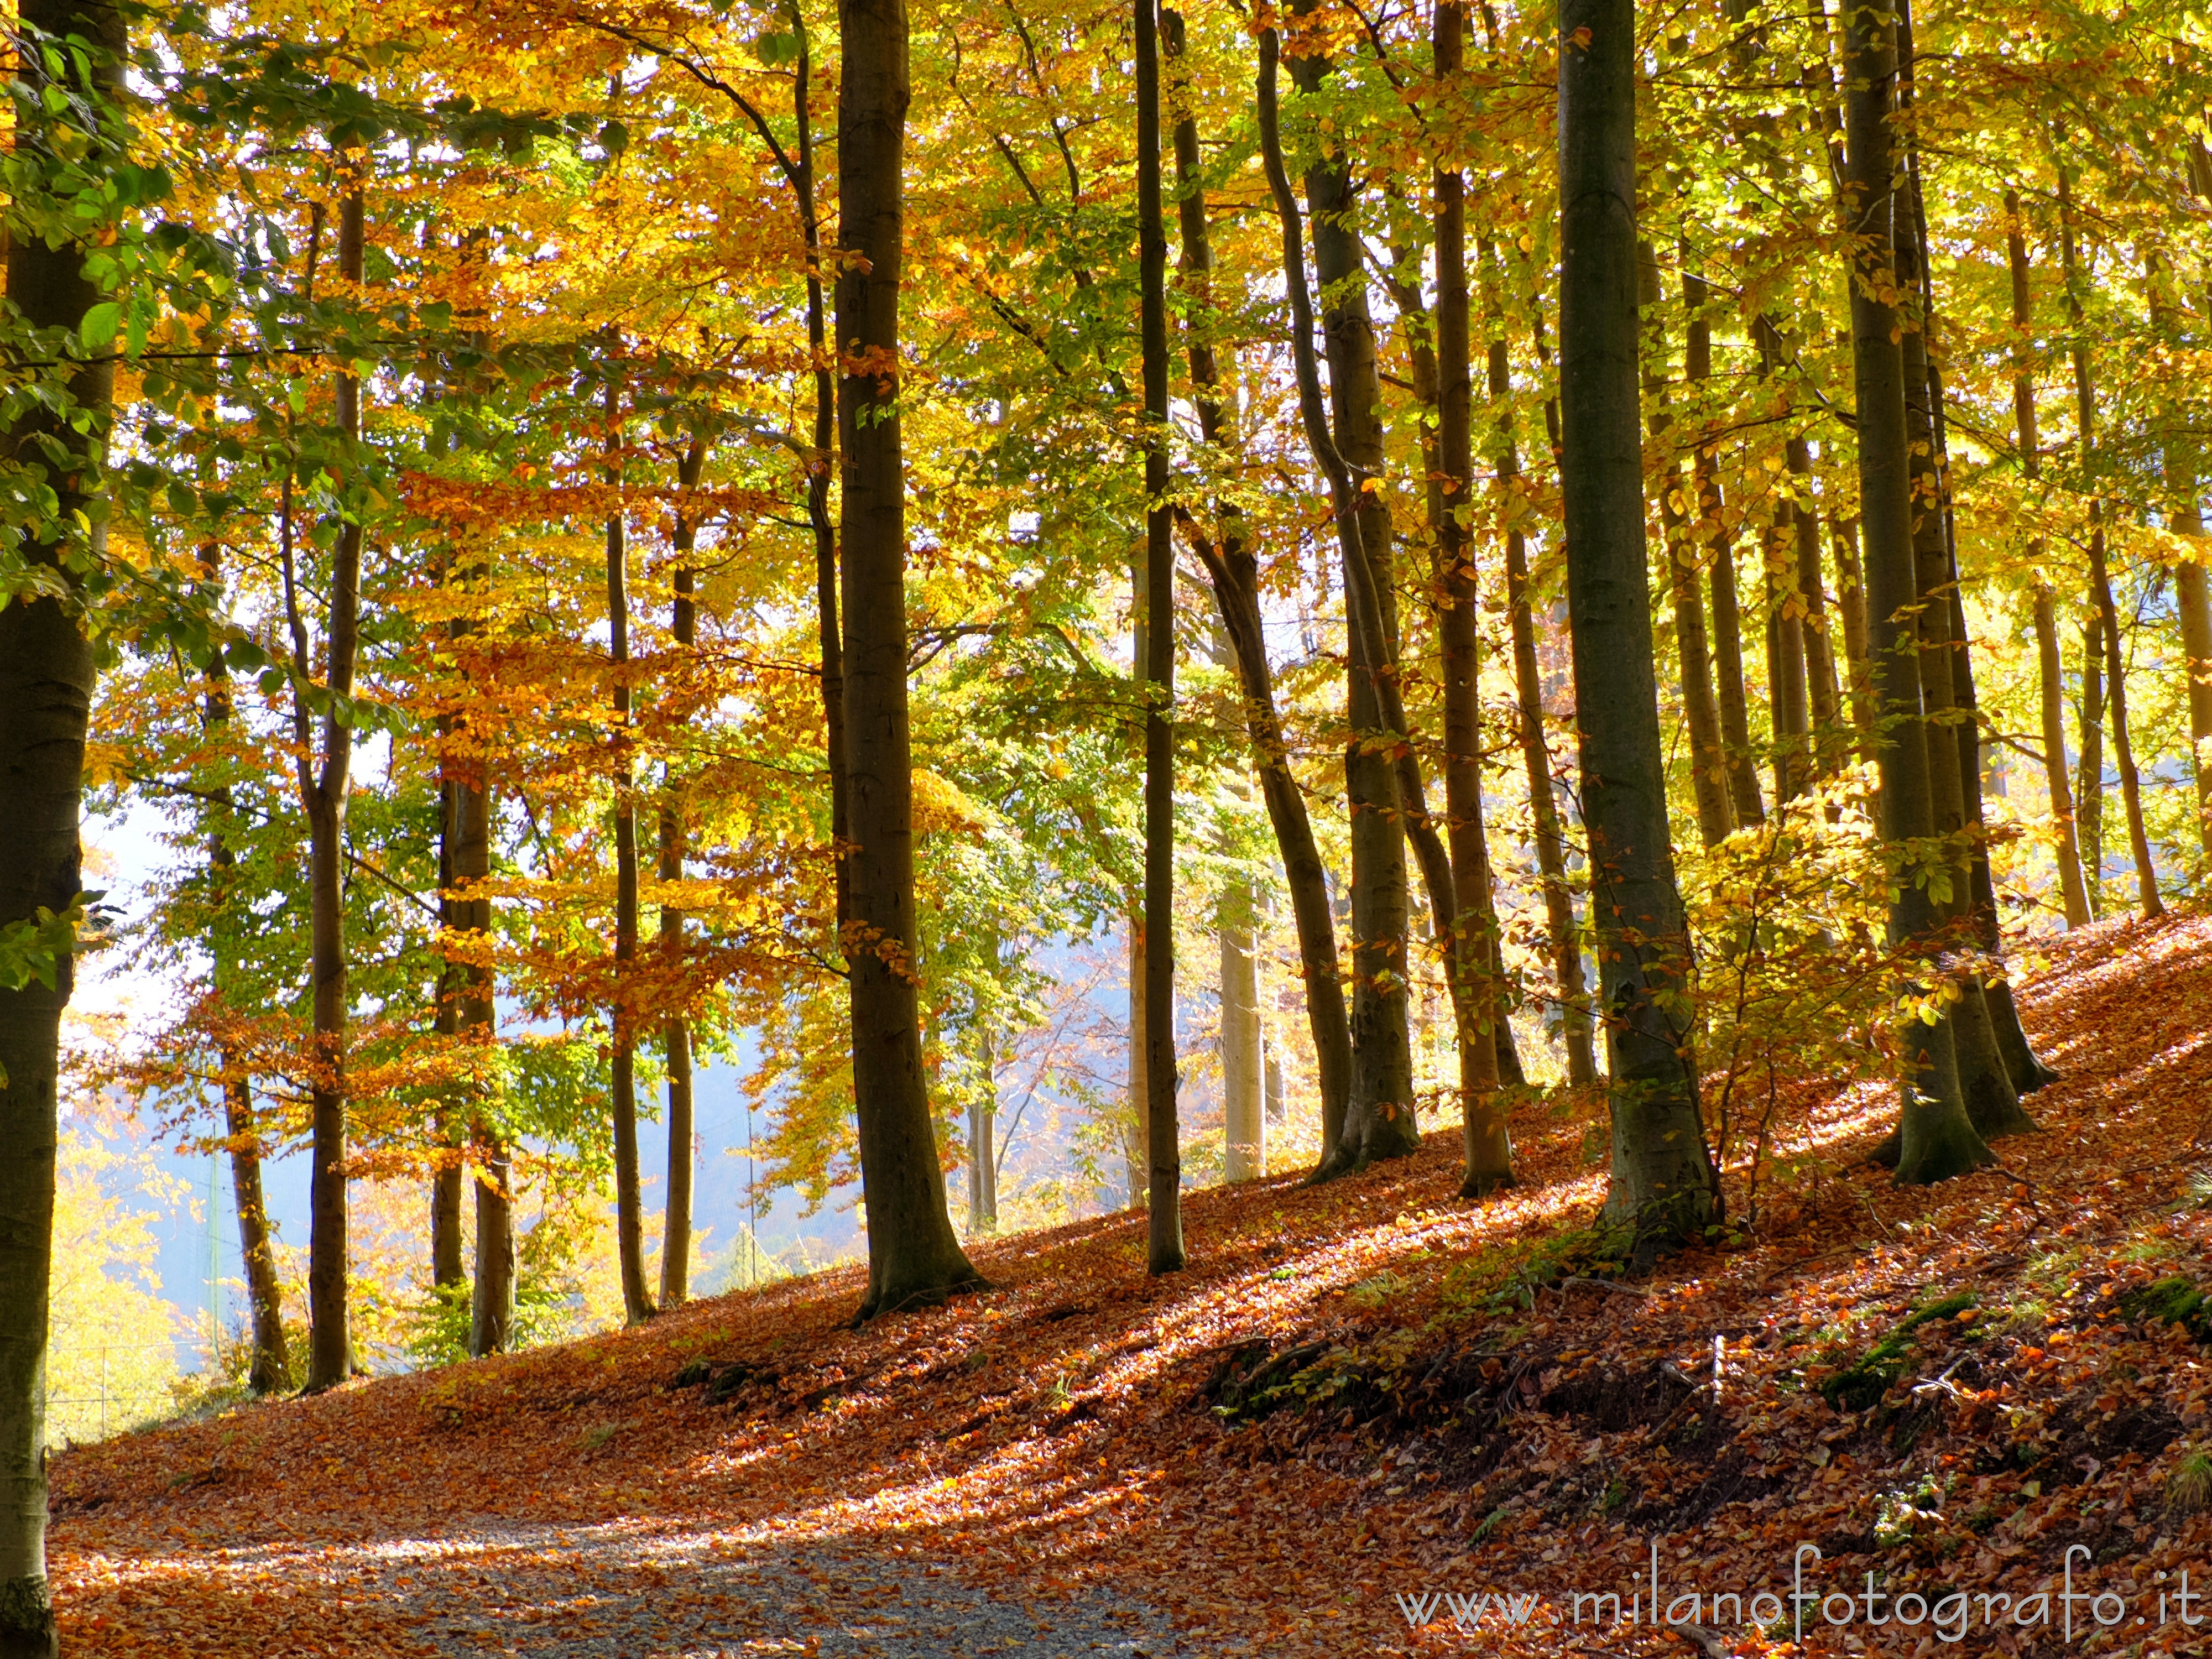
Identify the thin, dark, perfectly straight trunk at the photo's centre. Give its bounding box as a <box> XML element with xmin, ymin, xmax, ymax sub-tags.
<box><xmin>1137</xmin><ymin>0</ymin><xmax>1183</xmax><ymax>1274</ymax></box>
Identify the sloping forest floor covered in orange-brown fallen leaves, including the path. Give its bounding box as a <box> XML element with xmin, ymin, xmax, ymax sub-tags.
<box><xmin>51</xmin><ymin>916</ymin><xmax>2212</xmax><ymax>1659</ymax></box>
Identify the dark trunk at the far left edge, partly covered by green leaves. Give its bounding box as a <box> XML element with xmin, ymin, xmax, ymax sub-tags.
<box><xmin>0</xmin><ymin>0</ymin><xmax>124</xmax><ymax>1628</ymax></box>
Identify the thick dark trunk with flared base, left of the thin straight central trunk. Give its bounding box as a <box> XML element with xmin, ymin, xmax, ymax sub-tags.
<box><xmin>836</xmin><ymin>0</ymin><xmax>982</xmax><ymax>1321</ymax></box>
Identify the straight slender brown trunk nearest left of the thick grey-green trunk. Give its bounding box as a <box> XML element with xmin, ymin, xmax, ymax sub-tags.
<box><xmin>1431</xmin><ymin>0</ymin><xmax>1513</xmax><ymax>1199</ymax></box>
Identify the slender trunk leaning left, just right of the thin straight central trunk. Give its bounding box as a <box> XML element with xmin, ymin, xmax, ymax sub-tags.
<box><xmin>1161</xmin><ymin>11</ymin><xmax>1352</xmax><ymax>1146</ymax></box>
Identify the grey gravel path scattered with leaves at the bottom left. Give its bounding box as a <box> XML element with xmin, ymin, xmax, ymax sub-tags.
<box><xmin>276</xmin><ymin>1520</ymin><xmax>1192</xmax><ymax>1659</ymax></box>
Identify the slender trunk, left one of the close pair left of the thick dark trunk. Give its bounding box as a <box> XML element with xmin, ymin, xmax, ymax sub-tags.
<box><xmin>606</xmin><ymin>378</ymin><xmax>653</xmax><ymax>1325</ymax></box>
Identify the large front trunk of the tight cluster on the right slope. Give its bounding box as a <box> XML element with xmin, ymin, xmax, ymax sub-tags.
<box><xmin>1845</xmin><ymin>7</ymin><xmax>1991</xmax><ymax>1183</ymax></box>
